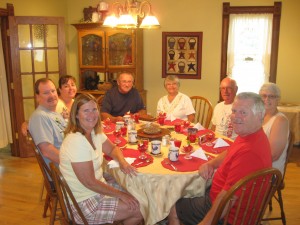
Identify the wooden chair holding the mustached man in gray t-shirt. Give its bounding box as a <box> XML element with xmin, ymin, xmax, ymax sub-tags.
<box><xmin>28</xmin><ymin>132</ymin><xmax>58</xmax><ymax>225</ymax></box>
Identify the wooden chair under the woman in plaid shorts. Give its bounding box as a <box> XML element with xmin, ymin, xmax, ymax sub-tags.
<box><xmin>50</xmin><ymin>162</ymin><xmax>122</xmax><ymax>225</ymax></box>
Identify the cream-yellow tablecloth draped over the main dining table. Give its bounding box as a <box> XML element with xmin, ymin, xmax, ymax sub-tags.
<box><xmin>105</xmin><ymin>125</ymin><xmax>210</xmax><ymax>225</ymax></box>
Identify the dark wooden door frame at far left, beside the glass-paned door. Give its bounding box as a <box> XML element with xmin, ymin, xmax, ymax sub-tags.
<box><xmin>0</xmin><ymin>3</ymin><xmax>18</xmax><ymax>156</ymax></box>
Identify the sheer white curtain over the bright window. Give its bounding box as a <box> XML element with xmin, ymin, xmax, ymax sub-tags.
<box><xmin>227</xmin><ymin>14</ymin><xmax>273</xmax><ymax>92</ymax></box>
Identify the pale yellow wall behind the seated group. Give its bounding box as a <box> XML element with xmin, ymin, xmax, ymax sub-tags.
<box><xmin>0</xmin><ymin>0</ymin><xmax>300</xmax><ymax>114</ymax></box>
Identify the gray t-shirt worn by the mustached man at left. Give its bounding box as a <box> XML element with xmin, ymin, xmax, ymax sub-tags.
<box><xmin>29</xmin><ymin>105</ymin><xmax>67</xmax><ymax>165</ymax></box>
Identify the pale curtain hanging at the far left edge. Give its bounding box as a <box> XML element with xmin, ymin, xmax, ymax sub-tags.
<box><xmin>0</xmin><ymin>30</ymin><xmax>12</xmax><ymax>148</ymax></box>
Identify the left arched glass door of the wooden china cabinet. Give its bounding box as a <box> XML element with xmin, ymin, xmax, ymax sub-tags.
<box><xmin>79</xmin><ymin>30</ymin><xmax>105</xmax><ymax>68</ymax></box>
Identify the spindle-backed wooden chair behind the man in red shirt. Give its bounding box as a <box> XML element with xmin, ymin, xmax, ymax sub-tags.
<box><xmin>211</xmin><ymin>168</ymin><xmax>282</xmax><ymax>225</ymax></box>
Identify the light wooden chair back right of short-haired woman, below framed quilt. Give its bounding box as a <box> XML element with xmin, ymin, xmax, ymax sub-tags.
<box><xmin>190</xmin><ymin>96</ymin><xmax>213</xmax><ymax>128</ymax></box>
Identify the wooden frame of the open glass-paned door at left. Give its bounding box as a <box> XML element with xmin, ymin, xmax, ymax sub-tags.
<box><xmin>8</xmin><ymin>16</ymin><xmax>66</xmax><ymax>157</ymax></box>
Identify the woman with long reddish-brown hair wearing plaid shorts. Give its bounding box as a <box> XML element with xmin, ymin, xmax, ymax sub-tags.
<box><xmin>59</xmin><ymin>94</ymin><xmax>143</xmax><ymax>225</ymax></box>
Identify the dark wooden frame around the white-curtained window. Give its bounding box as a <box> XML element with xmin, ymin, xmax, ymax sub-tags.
<box><xmin>219</xmin><ymin>2</ymin><xmax>282</xmax><ymax>101</ymax></box>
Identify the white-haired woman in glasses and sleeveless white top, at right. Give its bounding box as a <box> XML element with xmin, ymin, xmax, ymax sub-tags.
<box><xmin>259</xmin><ymin>83</ymin><xmax>289</xmax><ymax>174</ymax></box>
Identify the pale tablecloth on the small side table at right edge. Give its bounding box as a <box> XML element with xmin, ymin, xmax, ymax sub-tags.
<box><xmin>277</xmin><ymin>104</ymin><xmax>300</xmax><ymax>145</ymax></box>
